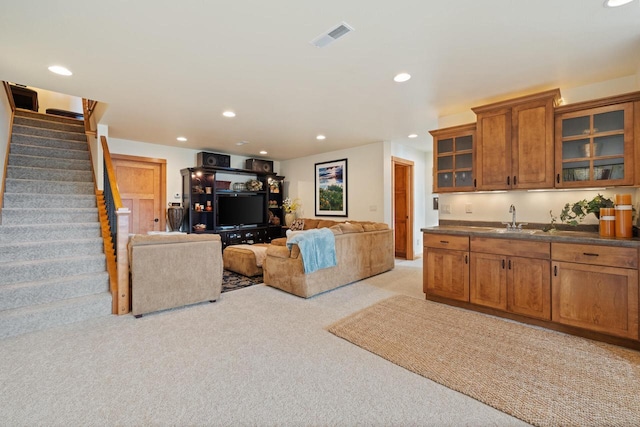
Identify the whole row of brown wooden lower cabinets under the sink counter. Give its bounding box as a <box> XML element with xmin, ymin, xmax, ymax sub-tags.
<box><xmin>423</xmin><ymin>227</ymin><xmax>640</xmax><ymax>349</ymax></box>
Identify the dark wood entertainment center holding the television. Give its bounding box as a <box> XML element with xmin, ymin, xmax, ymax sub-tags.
<box><xmin>180</xmin><ymin>166</ymin><xmax>284</xmax><ymax>248</ymax></box>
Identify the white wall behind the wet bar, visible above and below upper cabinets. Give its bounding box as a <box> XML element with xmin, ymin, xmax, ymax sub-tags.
<box><xmin>438</xmin><ymin>73</ymin><xmax>640</xmax><ymax>224</ymax></box>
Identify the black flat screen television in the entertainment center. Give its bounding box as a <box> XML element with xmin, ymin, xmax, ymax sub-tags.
<box><xmin>217</xmin><ymin>194</ymin><xmax>267</xmax><ymax>227</ymax></box>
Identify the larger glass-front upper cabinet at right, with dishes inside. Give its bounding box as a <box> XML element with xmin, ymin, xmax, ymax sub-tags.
<box><xmin>555</xmin><ymin>98</ymin><xmax>634</xmax><ymax>188</ymax></box>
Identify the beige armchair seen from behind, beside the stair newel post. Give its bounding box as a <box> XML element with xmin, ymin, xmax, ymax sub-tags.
<box><xmin>129</xmin><ymin>233</ymin><xmax>222</xmax><ymax>317</ymax></box>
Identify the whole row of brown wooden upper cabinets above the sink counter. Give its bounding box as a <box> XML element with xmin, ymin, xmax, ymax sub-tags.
<box><xmin>431</xmin><ymin>89</ymin><xmax>640</xmax><ymax>193</ymax></box>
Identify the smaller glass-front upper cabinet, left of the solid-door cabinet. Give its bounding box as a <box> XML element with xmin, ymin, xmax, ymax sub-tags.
<box><xmin>429</xmin><ymin>123</ymin><xmax>476</xmax><ymax>193</ymax></box>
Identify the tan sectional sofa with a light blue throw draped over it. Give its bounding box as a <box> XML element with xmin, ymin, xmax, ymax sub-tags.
<box><xmin>263</xmin><ymin>218</ymin><xmax>395</xmax><ymax>298</ymax></box>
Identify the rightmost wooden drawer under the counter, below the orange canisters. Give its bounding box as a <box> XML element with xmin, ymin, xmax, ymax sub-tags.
<box><xmin>551</xmin><ymin>243</ymin><xmax>638</xmax><ymax>268</ymax></box>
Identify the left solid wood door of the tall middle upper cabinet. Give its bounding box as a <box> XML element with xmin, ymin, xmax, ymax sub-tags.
<box><xmin>475</xmin><ymin>108</ymin><xmax>511</xmax><ymax>190</ymax></box>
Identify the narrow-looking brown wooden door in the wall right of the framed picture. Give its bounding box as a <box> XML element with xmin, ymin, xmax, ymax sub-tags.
<box><xmin>392</xmin><ymin>157</ymin><xmax>414</xmax><ymax>260</ymax></box>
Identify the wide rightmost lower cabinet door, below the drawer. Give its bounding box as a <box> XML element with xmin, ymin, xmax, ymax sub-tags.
<box><xmin>551</xmin><ymin>262</ymin><xmax>638</xmax><ymax>340</ymax></box>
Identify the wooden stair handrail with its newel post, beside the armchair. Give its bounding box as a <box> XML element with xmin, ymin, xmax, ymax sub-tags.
<box><xmin>100</xmin><ymin>136</ymin><xmax>131</xmax><ymax>314</ymax></box>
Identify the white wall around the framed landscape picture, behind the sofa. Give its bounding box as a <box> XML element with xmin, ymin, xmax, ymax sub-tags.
<box><xmin>280</xmin><ymin>142</ymin><xmax>382</xmax><ymax>223</ymax></box>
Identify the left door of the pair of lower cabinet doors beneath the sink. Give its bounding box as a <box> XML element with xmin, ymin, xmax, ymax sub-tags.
<box><xmin>469</xmin><ymin>252</ymin><xmax>507</xmax><ymax>310</ymax></box>
